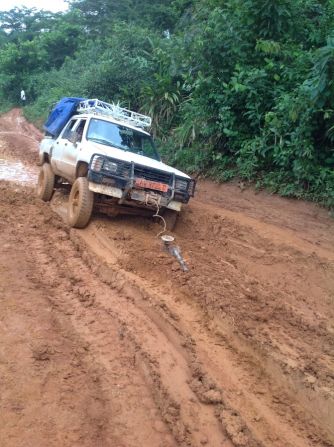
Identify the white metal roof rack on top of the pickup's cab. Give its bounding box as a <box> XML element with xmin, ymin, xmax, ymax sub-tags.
<box><xmin>77</xmin><ymin>99</ymin><xmax>152</xmax><ymax>127</ymax></box>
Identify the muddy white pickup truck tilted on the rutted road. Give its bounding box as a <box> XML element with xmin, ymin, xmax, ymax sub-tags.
<box><xmin>37</xmin><ymin>98</ymin><xmax>195</xmax><ymax>229</ymax></box>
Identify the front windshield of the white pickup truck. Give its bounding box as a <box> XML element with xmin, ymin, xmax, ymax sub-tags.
<box><xmin>86</xmin><ymin>118</ymin><xmax>160</xmax><ymax>160</ymax></box>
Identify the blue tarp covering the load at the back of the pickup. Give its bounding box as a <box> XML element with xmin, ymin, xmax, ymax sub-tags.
<box><xmin>43</xmin><ymin>98</ymin><xmax>85</xmax><ymax>137</ymax></box>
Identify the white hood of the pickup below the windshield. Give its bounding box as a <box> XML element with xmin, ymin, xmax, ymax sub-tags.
<box><xmin>85</xmin><ymin>141</ymin><xmax>190</xmax><ymax>178</ymax></box>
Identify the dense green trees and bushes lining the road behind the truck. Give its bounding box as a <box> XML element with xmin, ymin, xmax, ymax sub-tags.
<box><xmin>0</xmin><ymin>0</ymin><xmax>334</xmax><ymax>208</ymax></box>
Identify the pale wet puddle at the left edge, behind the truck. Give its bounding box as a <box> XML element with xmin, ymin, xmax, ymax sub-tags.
<box><xmin>0</xmin><ymin>157</ymin><xmax>38</xmax><ymax>185</ymax></box>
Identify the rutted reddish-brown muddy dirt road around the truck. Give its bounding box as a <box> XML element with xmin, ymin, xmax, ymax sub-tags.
<box><xmin>0</xmin><ymin>110</ymin><xmax>334</xmax><ymax>447</ymax></box>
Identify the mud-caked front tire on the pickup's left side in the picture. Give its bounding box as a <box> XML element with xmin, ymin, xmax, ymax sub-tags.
<box><xmin>67</xmin><ymin>177</ymin><xmax>94</xmax><ymax>228</ymax></box>
